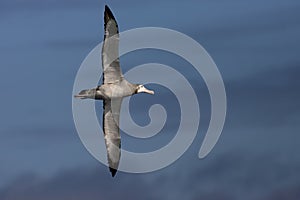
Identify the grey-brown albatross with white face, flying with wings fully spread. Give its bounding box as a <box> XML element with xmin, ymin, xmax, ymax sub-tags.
<box><xmin>75</xmin><ymin>6</ymin><xmax>154</xmax><ymax>177</ymax></box>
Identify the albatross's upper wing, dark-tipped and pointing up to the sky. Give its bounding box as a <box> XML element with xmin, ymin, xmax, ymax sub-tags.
<box><xmin>102</xmin><ymin>6</ymin><xmax>123</xmax><ymax>83</ymax></box>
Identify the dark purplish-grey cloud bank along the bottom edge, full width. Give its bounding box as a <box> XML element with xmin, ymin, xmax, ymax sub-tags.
<box><xmin>0</xmin><ymin>150</ymin><xmax>299</xmax><ymax>200</ymax></box>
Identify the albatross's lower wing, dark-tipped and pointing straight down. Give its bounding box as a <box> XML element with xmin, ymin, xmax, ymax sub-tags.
<box><xmin>103</xmin><ymin>98</ymin><xmax>122</xmax><ymax>176</ymax></box>
